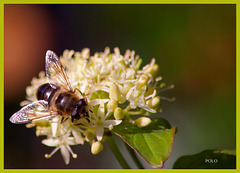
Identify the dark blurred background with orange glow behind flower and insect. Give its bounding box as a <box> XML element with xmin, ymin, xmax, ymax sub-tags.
<box><xmin>4</xmin><ymin>5</ymin><xmax>236</xmax><ymax>168</ymax></box>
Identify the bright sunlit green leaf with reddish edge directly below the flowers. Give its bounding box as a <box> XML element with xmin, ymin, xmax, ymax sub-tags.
<box><xmin>112</xmin><ymin>118</ymin><xmax>176</xmax><ymax>168</ymax></box>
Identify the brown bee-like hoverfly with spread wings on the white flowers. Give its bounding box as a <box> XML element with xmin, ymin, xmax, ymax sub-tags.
<box><xmin>10</xmin><ymin>50</ymin><xmax>89</xmax><ymax>124</ymax></box>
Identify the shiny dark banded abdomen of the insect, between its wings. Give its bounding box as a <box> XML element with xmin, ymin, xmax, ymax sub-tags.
<box><xmin>37</xmin><ymin>83</ymin><xmax>60</xmax><ymax>106</ymax></box>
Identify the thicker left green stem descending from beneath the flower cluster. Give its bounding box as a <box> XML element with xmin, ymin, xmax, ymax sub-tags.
<box><xmin>107</xmin><ymin>135</ymin><xmax>131</xmax><ymax>169</ymax></box>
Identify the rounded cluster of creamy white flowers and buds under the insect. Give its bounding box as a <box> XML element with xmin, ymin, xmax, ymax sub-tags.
<box><xmin>22</xmin><ymin>47</ymin><xmax>173</xmax><ymax>164</ymax></box>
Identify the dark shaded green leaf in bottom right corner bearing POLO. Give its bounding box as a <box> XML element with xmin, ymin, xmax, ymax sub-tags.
<box><xmin>173</xmin><ymin>150</ymin><xmax>236</xmax><ymax>169</ymax></box>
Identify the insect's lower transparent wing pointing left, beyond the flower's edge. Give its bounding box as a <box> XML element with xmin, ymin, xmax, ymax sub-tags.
<box><xmin>9</xmin><ymin>100</ymin><xmax>57</xmax><ymax>124</ymax></box>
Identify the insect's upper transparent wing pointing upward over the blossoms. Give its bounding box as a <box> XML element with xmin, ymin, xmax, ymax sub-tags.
<box><xmin>45</xmin><ymin>50</ymin><xmax>73</xmax><ymax>91</ymax></box>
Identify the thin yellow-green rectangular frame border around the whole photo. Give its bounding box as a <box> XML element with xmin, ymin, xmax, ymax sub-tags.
<box><xmin>0</xmin><ymin>0</ymin><xmax>240</xmax><ymax>173</ymax></box>
